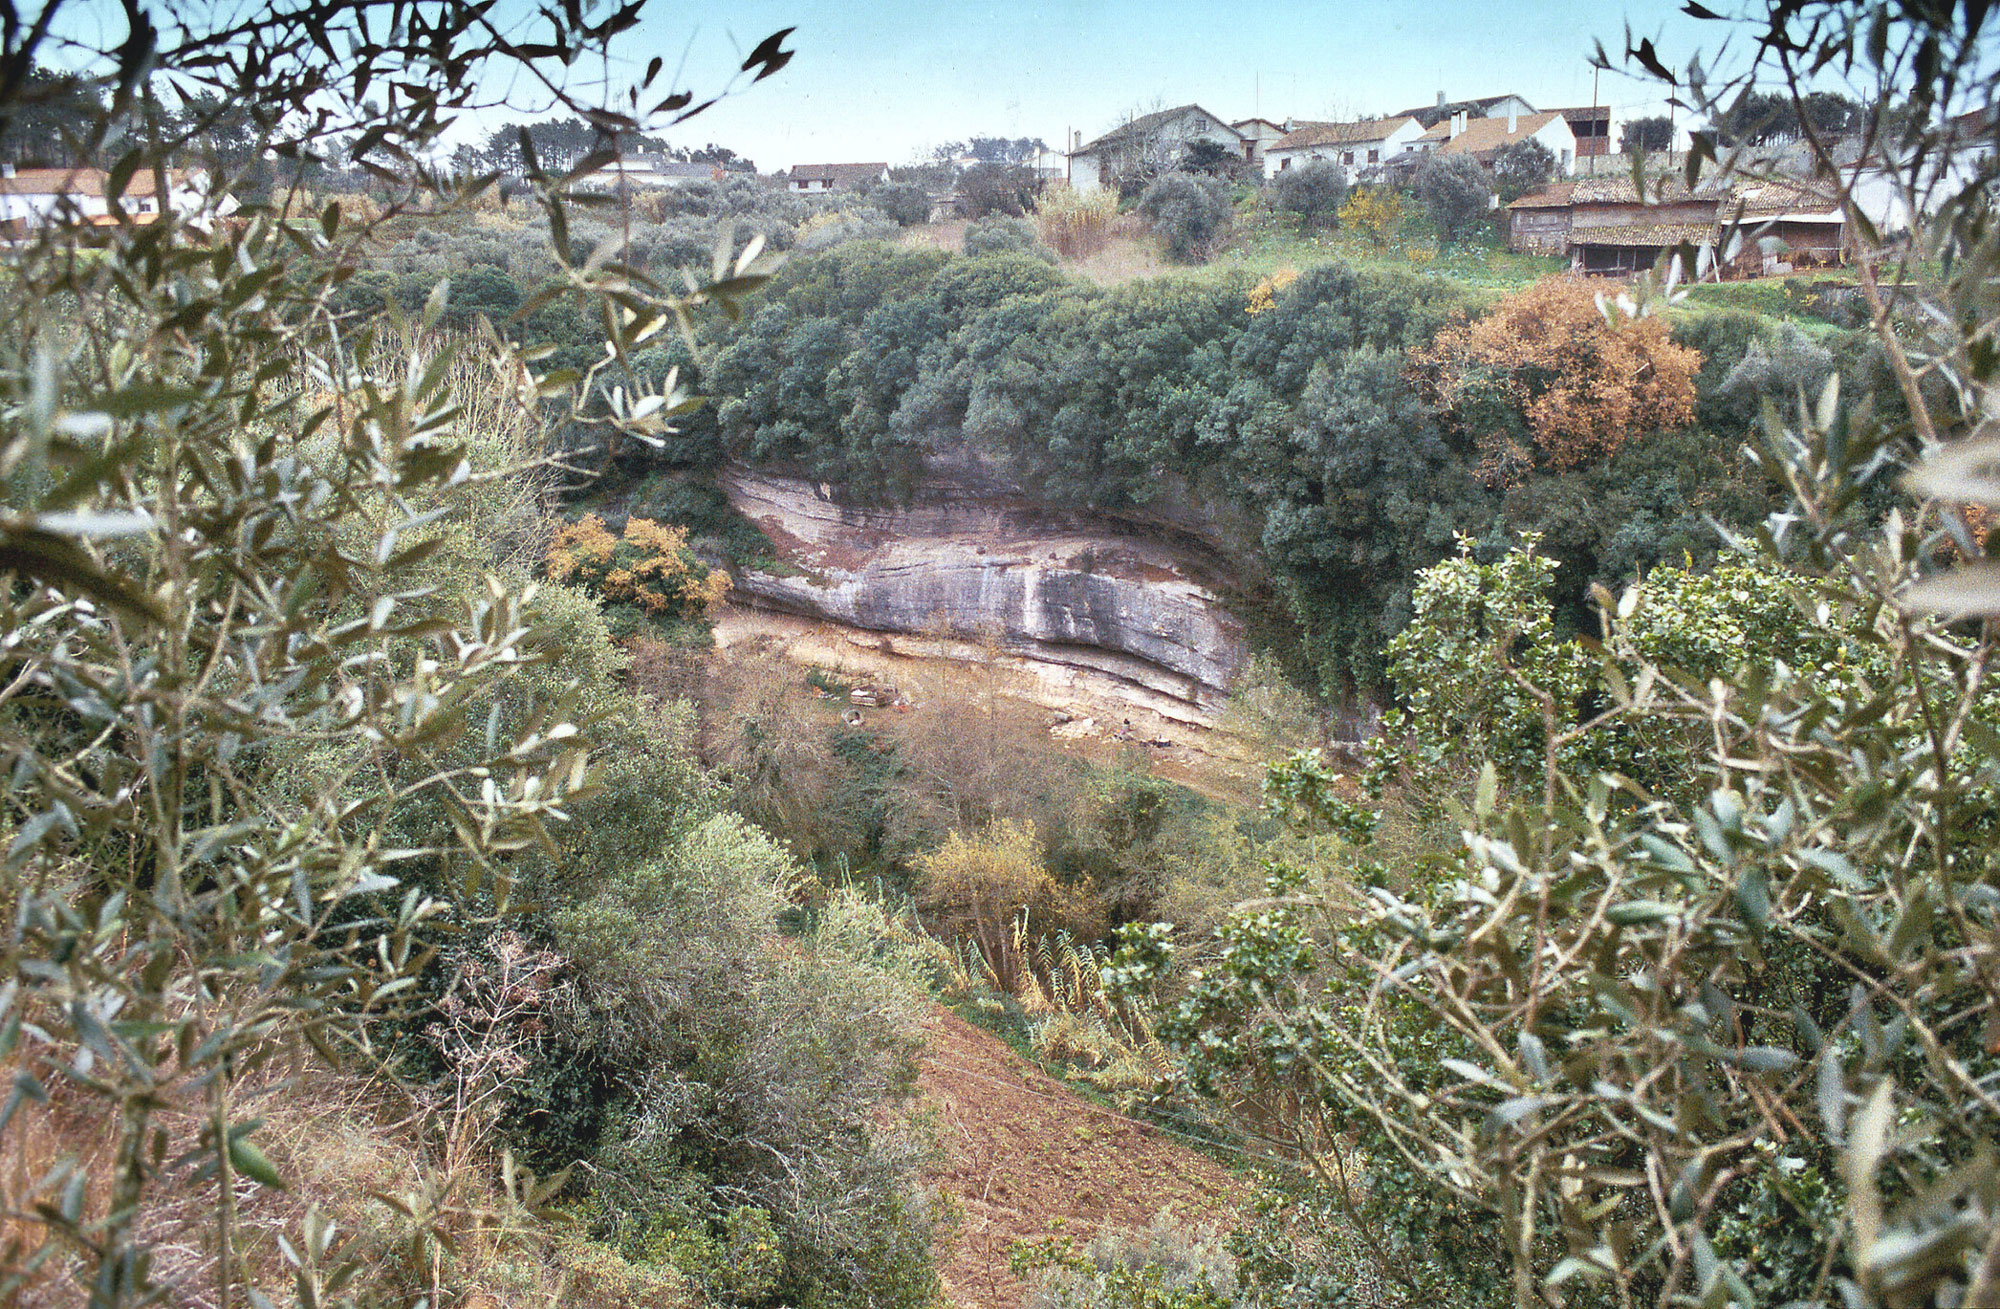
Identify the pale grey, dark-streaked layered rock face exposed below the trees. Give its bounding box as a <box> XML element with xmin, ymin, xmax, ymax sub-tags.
<box><xmin>722</xmin><ymin>468</ymin><xmax>1244</xmax><ymax>721</ymax></box>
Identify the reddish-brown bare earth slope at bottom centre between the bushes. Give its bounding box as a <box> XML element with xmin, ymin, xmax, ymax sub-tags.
<box><xmin>918</xmin><ymin>1009</ymin><xmax>1250</xmax><ymax>1309</ymax></box>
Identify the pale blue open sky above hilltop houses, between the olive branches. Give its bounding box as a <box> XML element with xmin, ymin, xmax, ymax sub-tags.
<box><xmin>584</xmin><ymin>0</ymin><xmax>1718</xmax><ymax>172</ymax></box>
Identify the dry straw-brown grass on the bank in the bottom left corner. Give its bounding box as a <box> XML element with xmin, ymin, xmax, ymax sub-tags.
<box><xmin>0</xmin><ymin>1004</ymin><xmax>700</xmax><ymax>1309</ymax></box>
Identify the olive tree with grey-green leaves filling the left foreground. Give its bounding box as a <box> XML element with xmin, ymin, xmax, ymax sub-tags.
<box><xmin>0</xmin><ymin>0</ymin><xmax>790</xmax><ymax>1309</ymax></box>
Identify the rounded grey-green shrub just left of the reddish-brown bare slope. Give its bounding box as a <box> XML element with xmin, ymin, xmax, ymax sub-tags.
<box><xmin>532</xmin><ymin>832</ymin><xmax>936</xmax><ymax>1305</ymax></box>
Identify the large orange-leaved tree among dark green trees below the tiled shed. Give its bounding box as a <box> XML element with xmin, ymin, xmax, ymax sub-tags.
<box><xmin>1416</xmin><ymin>276</ymin><xmax>1702</xmax><ymax>482</ymax></box>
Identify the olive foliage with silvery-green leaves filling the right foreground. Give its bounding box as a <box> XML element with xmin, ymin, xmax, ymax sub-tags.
<box><xmin>1176</xmin><ymin>2</ymin><xmax>2000</xmax><ymax>1309</ymax></box>
